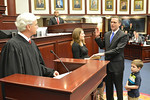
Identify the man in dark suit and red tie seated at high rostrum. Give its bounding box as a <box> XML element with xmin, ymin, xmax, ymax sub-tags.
<box><xmin>49</xmin><ymin>10</ymin><xmax>64</xmax><ymax>25</ymax></box>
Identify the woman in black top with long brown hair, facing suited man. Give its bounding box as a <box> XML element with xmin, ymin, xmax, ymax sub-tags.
<box><xmin>71</xmin><ymin>28</ymin><xmax>89</xmax><ymax>59</ymax></box>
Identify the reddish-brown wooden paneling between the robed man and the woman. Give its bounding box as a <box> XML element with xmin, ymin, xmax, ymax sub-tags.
<box><xmin>33</xmin><ymin>35</ymin><xmax>72</xmax><ymax>68</ymax></box>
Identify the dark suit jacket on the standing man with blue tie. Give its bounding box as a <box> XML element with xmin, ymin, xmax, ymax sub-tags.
<box><xmin>95</xmin><ymin>30</ymin><xmax>127</xmax><ymax>72</ymax></box>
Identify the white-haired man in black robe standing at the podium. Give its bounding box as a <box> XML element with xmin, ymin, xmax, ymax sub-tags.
<box><xmin>0</xmin><ymin>13</ymin><xmax>59</xmax><ymax>99</ymax></box>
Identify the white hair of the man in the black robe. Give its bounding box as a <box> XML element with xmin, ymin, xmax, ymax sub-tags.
<box><xmin>15</xmin><ymin>13</ymin><xmax>37</xmax><ymax>32</ymax></box>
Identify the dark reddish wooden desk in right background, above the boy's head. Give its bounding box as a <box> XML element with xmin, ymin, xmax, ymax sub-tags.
<box><xmin>124</xmin><ymin>44</ymin><xmax>150</xmax><ymax>62</ymax></box>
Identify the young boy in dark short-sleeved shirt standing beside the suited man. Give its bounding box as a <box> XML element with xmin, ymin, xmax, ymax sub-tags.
<box><xmin>125</xmin><ymin>59</ymin><xmax>143</xmax><ymax>100</ymax></box>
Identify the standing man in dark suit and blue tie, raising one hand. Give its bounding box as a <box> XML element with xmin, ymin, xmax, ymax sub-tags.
<box><xmin>93</xmin><ymin>16</ymin><xmax>127</xmax><ymax>100</ymax></box>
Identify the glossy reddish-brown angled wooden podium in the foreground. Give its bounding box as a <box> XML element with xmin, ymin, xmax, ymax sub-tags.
<box><xmin>0</xmin><ymin>58</ymin><xmax>109</xmax><ymax>100</ymax></box>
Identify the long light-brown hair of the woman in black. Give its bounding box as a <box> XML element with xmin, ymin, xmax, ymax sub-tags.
<box><xmin>71</xmin><ymin>28</ymin><xmax>85</xmax><ymax>46</ymax></box>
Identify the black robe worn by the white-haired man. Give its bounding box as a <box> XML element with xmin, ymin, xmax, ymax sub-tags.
<box><xmin>0</xmin><ymin>35</ymin><xmax>54</xmax><ymax>78</ymax></box>
